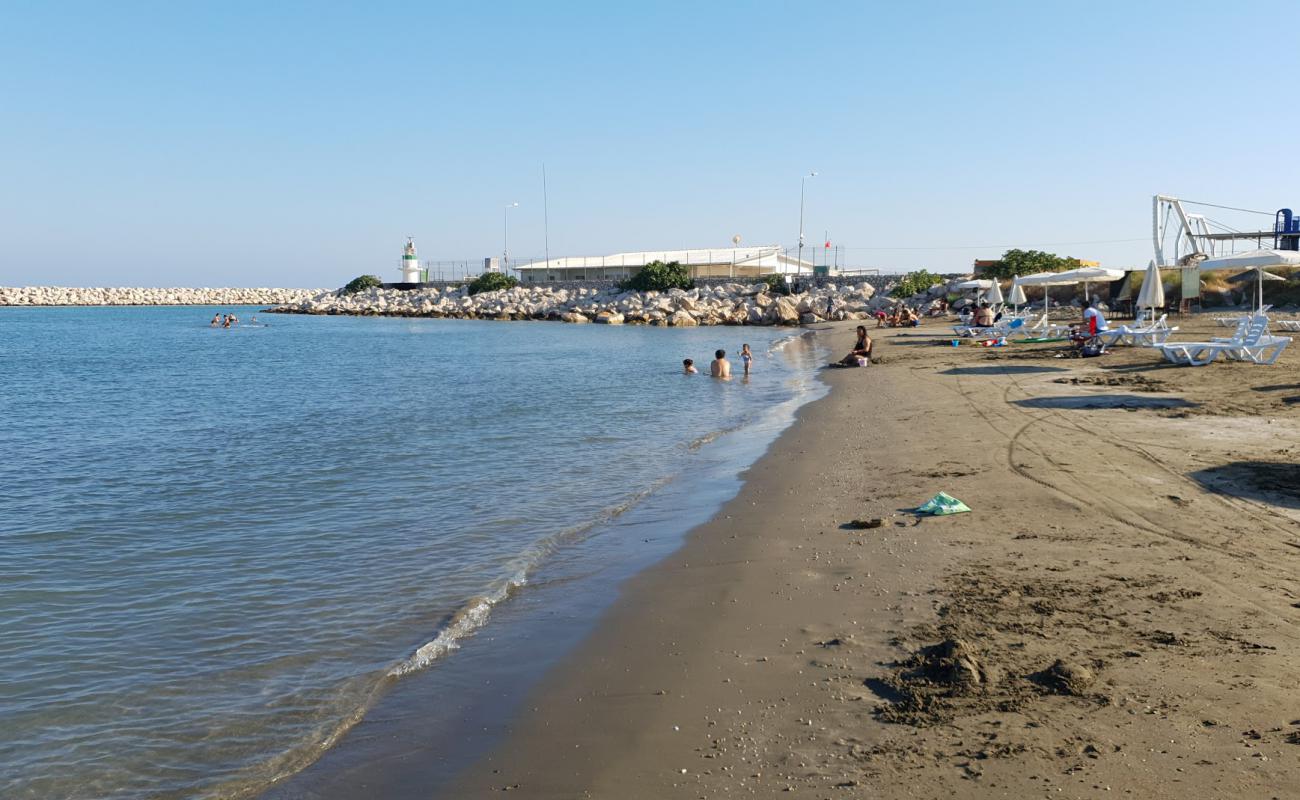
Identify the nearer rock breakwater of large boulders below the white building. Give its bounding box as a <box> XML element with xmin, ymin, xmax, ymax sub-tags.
<box><xmin>272</xmin><ymin>282</ymin><xmax>977</xmax><ymax>325</ymax></box>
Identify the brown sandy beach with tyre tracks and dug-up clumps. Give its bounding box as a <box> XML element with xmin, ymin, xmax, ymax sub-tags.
<box><xmin>439</xmin><ymin>317</ymin><xmax>1300</xmax><ymax>797</ymax></box>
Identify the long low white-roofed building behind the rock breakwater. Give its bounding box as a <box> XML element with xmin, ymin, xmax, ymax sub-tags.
<box><xmin>516</xmin><ymin>245</ymin><xmax>813</xmax><ymax>284</ymax></box>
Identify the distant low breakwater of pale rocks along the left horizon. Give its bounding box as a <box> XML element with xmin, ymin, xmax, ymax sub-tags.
<box><xmin>0</xmin><ymin>286</ymin><xmax>326</xmax><ymax>306</ymax></box>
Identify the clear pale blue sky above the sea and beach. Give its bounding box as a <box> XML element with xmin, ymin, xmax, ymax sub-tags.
<box><xmin>0</xmin><ymin>0</ymin><xmax>1300</xmax><ymax>286</ymax></box>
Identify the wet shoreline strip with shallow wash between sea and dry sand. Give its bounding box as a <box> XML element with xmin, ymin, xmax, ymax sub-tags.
<box><xmin>253</xmin><ymin>332</ymin><xmax>826</xmax><ymax>800</ymax></box>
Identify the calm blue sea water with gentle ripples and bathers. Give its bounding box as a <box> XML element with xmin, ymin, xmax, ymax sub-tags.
<box><xmin>0</xmin><ymin>307</ymin><xmax>811</xmax><ymax>799</ymax></box>
